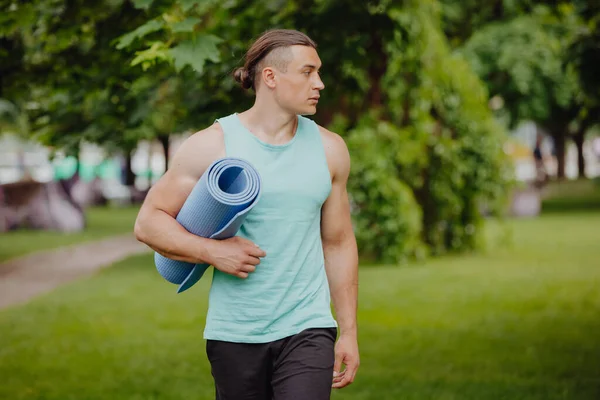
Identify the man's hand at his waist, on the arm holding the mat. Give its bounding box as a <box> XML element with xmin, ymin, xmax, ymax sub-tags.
<box><xmin>208</xmin><ymin>236</ymin><xmax>266</xmax><ymax>279</ymax></box>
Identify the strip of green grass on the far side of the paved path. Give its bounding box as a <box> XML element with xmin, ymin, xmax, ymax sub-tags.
<box><xmin>0</xmin><ymin>206</ymin><xmax>139</xmax><ymax>262</ymax></box>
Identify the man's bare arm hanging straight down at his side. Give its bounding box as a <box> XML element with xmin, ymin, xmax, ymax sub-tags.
<box><xmin>321</xmin><ymin>127</ymin><xmax>359</xmax><ymax>388</ymax></box>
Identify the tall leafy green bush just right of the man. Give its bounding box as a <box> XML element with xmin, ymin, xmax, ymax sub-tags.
<box><xmin>333</xmin><ymin>2</ymin><xmax>510</xmax><ymax>262</ymax></box>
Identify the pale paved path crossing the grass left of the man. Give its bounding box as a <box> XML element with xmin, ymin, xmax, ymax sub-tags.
<box><xmin>0</xmin><ymin>235</ymin><xmax>150</xmax><ymax>309</ymax></box>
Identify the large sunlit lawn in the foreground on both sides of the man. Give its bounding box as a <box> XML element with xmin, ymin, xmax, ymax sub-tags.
<box><xmin>0</xmin><ymin>212</ymin><xmax>600</xmax><ymax>400</ymax></box>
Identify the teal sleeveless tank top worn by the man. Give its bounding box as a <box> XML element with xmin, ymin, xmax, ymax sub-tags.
<box><xmin>204</xmin><ymin>114</ymin><xmax>337</xmax><ymax>343</ymax></box>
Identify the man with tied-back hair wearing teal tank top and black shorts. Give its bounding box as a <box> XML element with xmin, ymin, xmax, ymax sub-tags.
<box><xmin>135</xmin><ymin>30</ymin><xmax>359</xmax><ymax>400</ymax></box>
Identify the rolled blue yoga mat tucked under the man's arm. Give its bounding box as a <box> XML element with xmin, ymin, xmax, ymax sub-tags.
<box><xmin>154</xmin><ymin>157</ymin><xmax>261</xmax><ymax>293</ymax></box>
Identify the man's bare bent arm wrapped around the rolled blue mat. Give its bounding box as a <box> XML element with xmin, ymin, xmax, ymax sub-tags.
<box><xmin>134</xmin><ymin>124</ymin><xmax>264</xmax><ymax>278</ymax></box>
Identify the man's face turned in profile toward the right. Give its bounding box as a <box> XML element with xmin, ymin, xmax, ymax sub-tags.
<box><xmin>274</xmin><ymin>46</ymin><xmax>325</xmax><ymax>115</ymax></box>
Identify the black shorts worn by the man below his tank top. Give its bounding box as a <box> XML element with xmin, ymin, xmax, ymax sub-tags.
<box><xmin>206</xmin><ymin>328</ymin><xmax>337</xmax><ymax>400</ymax></box>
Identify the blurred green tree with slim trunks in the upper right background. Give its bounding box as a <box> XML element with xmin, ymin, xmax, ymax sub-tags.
<box><xmin>441</xmin><ymin>0</ymin><xmax>600</xmax><ymax>179</ymax></box>
